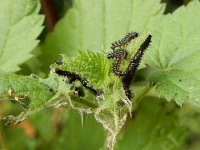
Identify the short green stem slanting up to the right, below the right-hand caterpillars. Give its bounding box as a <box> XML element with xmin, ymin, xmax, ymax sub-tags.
<box><xmin>132</xmin><ymin>83</ymin><xmax>154</xmax><ymax>110</ymax></box>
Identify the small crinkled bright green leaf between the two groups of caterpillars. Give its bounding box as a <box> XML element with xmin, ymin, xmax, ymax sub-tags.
<box><xmin>54</xmin><ymin>51</ymin><xmax>111</xmax><ymax>88</ymax></box>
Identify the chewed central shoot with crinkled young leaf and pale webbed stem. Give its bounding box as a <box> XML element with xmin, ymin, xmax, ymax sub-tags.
<box><xmin>52</xmin><ymin>51</ymin><xmax>131</xmax><ymax>149</ymax></box>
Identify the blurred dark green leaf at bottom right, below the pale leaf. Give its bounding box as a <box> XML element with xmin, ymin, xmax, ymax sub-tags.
<box><xmin>117</xmin><ymin>97</ymin><xmax>187</xmax><ymax>150</ymax></box>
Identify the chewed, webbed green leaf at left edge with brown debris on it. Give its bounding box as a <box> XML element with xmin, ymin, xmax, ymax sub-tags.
<box><xmin>0</xmin><ymin>72</ymin><xmax>72</xmax><ymax>124</ymax></box>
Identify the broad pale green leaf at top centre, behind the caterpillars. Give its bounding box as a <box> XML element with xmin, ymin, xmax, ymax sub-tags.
<box><xmin>41</xmin><ymin>0</ymin><xmax>165</xmax><ymax>70</ymax></box>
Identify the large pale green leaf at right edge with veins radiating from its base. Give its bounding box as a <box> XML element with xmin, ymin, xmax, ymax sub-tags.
<box><xmin>146</xmin><ymin>1</ymin><xmax>200</xmax><ymax>106</ymax></box>
